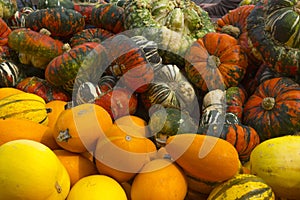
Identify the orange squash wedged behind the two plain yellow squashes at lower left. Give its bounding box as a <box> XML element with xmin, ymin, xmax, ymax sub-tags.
<box><xmin>53</xmin><ymin>149</ymin><xmax>98</xmax><ymax>187</ymax></box>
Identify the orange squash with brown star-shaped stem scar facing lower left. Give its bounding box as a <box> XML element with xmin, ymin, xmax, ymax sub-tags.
<box><xmin>53</xmin><ymin>103</ymin><xmax>113</xmax><ymax>153</ymax></box>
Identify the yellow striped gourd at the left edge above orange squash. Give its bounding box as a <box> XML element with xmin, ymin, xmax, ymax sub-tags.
<box><xmin>0</xmin><ymin>92</ymin><xmax>48</xmax><ymax>125</ymax></box>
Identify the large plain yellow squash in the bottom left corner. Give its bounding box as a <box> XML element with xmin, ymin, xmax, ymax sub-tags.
<box><xmin>0</xmin><ymin>139</ymin><xmax>70</xmax><ymax>200</ymax></box>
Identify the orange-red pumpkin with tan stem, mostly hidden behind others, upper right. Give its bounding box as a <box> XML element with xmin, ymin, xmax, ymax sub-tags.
<box><xmin>216</xmin><ymin>5</ymin><xmax>262</xmax><ymax>63</ymax></box>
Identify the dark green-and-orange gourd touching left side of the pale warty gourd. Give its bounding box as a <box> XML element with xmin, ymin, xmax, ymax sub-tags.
<box><xmin>90</xmin><ymin>3</ymin><xmax>125</xmax><ymax>34</ymax></box>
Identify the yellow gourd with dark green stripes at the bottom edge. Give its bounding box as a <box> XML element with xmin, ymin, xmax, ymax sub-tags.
<box><xmin>207</xmin><ymin>174</ymin><xmax>275</xmax><ymax>200</ymax></box>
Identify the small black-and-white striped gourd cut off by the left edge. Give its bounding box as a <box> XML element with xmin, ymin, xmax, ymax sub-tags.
<box><xmin>0</xmin><ymin>61</ymin><xmax>24</xmax><ymax>87</ymax></box>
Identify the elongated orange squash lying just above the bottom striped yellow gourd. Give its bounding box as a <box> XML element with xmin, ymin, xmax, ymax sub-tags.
<box><xmin>165</xmin><ymin>133</ymin><xmax>240</xmax><ymax>182</ymax></box>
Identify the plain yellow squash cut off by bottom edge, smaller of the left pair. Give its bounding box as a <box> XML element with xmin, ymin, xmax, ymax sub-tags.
<box><xmin>67</xmin><ymin>175</ymin><xmax>127</xmax><ymax>200</ymax></box>
